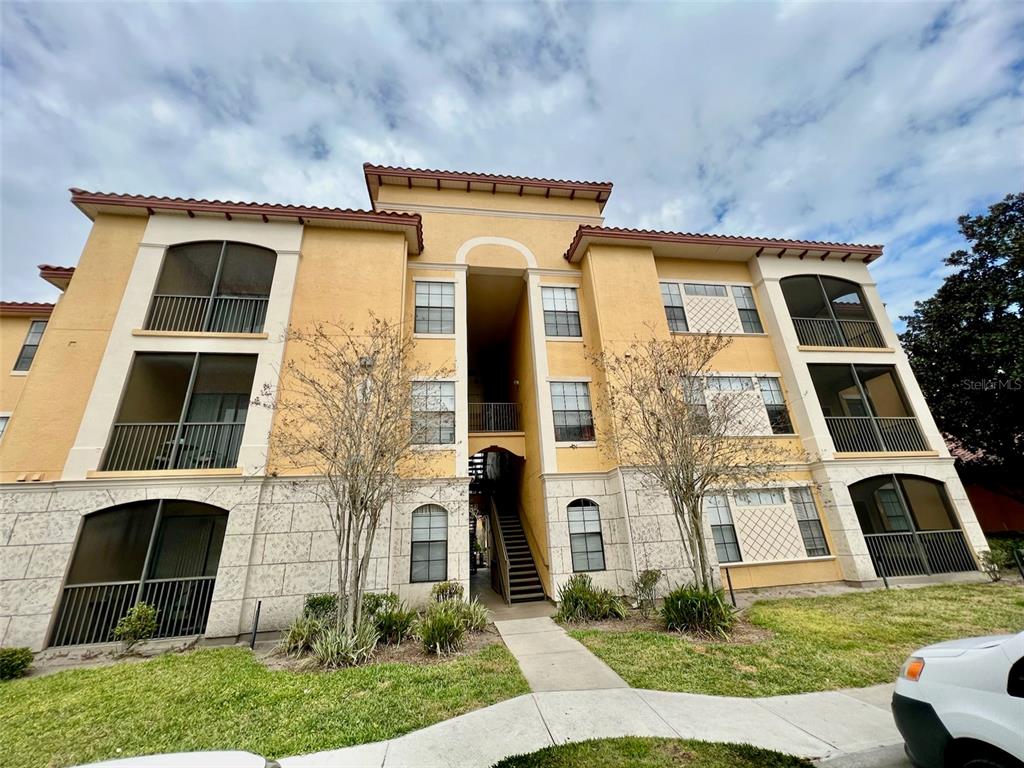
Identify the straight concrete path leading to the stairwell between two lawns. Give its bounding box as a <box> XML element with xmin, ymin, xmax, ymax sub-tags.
<box><xmin>495</xmin><ymin>616</ymin><xmax>629</xmax><ymax>692</ymax></box>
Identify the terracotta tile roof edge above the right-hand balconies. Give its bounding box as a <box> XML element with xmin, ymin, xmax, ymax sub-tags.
<box><xmin>564</xmin><ymin>226</ymin><xmax>883</xmax><ymax>263</ymax></box>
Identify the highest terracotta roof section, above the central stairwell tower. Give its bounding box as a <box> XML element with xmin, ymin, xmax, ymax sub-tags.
<box><xmin>362</xmin><ymin>163</ymin><xmax>612</xmax><ymax>210</ymax></box>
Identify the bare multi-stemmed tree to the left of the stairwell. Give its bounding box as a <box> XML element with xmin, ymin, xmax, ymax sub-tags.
<box><xmin>255</xmin><ymin>314</ymin><xmax>444</xmax><ymax>633</ymax></box>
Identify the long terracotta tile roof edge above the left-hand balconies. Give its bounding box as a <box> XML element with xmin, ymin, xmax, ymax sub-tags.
<box><xmin>70</xmin><ymin>187</ymin><xmax>423</xmax><ymax>254</ymax></box>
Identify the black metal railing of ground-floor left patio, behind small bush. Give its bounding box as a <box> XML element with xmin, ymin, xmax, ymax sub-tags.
<box><xmin>50</xmin><ymin>577</ymin><xmax>215</xmax><ymax>645</ymax></box>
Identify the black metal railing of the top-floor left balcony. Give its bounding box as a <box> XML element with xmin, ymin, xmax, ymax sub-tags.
<box><xmin>145</xmin><ymin>294</ymin><xmax>269</xmax><ymax>334</ymax></box>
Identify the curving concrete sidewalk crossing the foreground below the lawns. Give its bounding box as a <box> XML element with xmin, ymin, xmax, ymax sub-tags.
<box><xmin>280</xmin><ymin>685</ymin><xmax>902</xmax><ymax>768</ymax></box>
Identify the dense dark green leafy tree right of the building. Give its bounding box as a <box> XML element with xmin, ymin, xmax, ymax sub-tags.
<box><xmin>900</xmin><ymin>193</ymin><xmax>1024</xmax><ymax>485</ymax></box>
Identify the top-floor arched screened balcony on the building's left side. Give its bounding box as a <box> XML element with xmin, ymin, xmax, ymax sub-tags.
<box><xmin>145</xmin><ymin>242</ymin><xmax>278</xmax><ymax>334</ymax></box>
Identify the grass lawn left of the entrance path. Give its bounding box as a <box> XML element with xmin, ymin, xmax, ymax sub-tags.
<box><xmin>0</xmin><ymin>645</ymin><xmax>529</xmax><ymax>768</ymax></box>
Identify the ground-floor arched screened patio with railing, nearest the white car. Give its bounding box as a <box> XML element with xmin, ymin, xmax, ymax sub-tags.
<box><xmin>850</xmin><ymin>474</ymin><xmax>978</xmax><ymax>578</ymax></box>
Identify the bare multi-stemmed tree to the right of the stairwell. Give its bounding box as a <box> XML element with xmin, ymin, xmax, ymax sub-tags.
<box><xmin>592</xmin><ymin>331</ymin><xmax>795</xmax><ymax>589</ymax></box>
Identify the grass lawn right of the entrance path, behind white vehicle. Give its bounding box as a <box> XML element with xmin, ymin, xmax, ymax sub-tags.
<box><xmin>569</xmin><ymin>584</ymin><xmax>1024</xmax><ymax>696</ymax></box>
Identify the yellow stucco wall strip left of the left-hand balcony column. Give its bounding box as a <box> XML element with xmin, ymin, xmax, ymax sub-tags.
<box><xmin>0</xmin><ymin>214</ymin><xmax>147</xmax><ymax>482</ymax></box>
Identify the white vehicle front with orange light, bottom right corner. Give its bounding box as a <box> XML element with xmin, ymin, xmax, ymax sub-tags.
<box><xmin>893</xmin><ymin>632</ymin><xmax>1024</xmax><ymax>768</ymax></box>
